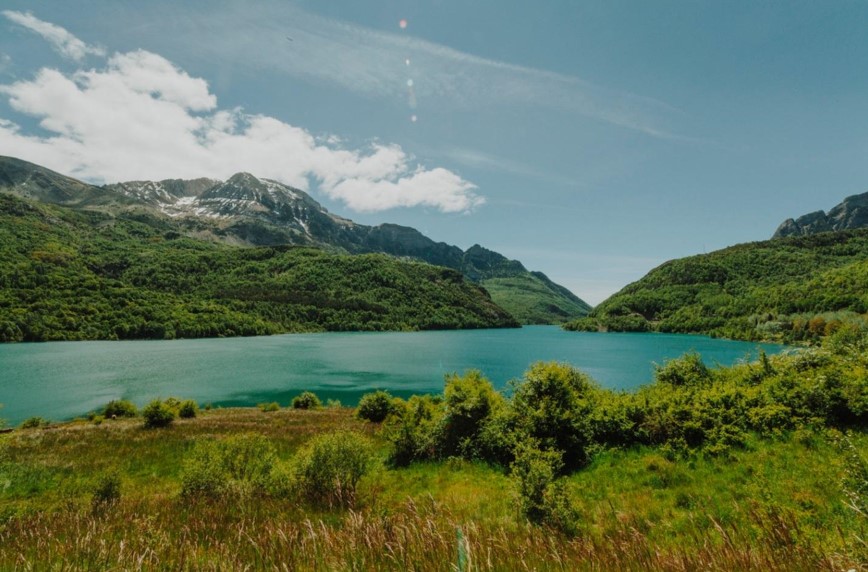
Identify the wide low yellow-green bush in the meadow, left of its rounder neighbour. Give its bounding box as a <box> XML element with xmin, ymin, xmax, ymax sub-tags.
<box><xmin>181</xmin><ymin>433</ymin><xmax>277</xmax><ymax>498</ymax></box>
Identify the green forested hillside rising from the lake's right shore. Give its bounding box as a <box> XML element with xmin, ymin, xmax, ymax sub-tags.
<box><xmin>565</xmin><ymin>230</ymin><xmax>868</xmax><ymax>342</ymax></box>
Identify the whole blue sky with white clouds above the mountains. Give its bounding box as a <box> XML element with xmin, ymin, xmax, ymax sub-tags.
<box><xmin>0</xmin><ymin>0</ymin><xmax>868</xmax><ymax>303</ymax></box>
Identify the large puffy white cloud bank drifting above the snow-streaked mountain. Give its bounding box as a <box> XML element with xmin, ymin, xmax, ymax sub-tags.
<box><xmin>0</xmin><ymin>50</ymin><xmax>483</xmax><ymax>212</ymax></box>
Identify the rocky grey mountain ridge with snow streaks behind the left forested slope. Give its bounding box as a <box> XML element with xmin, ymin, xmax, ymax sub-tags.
<box><xmin>0</xmin><ymin>157</ymin><xmax>591</xmax><ymax>324</ymax></box>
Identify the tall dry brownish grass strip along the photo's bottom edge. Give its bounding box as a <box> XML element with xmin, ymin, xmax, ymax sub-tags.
<box><xmin>0</xmin><ymin>498</ymin><xmax>856</xmax><ymax>572</ymax></box>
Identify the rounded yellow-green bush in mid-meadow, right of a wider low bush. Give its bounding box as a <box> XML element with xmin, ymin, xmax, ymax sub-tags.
<box><xmin>295</xmin><ymin>431</ymin><xmax>373</xmax><ymax>507</ymax></box>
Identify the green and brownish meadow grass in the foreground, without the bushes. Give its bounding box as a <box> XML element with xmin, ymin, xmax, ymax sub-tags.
<box><xmin>0</xmin><ymin>408</ymin><xmax>868</xmax><ymax>570</ymax></box>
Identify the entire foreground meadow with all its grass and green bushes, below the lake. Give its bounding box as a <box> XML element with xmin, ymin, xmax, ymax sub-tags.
<box><xmin>0</xmin><ymin>328</ymin><xmax>868</xmax><ymax>571</ymax></box>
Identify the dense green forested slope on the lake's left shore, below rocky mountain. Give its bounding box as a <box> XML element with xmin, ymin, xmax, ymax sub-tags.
<box><xmin>0</xmin><ymin>195</ymin><xmax>517</xmax><ymax>342</ymax></box>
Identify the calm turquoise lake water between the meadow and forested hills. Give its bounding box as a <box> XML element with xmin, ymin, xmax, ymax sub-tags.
<box><xmin>0</xmin><ymin>326</ymin><xmax>784</xmax><ymax>425</ymax></box>
